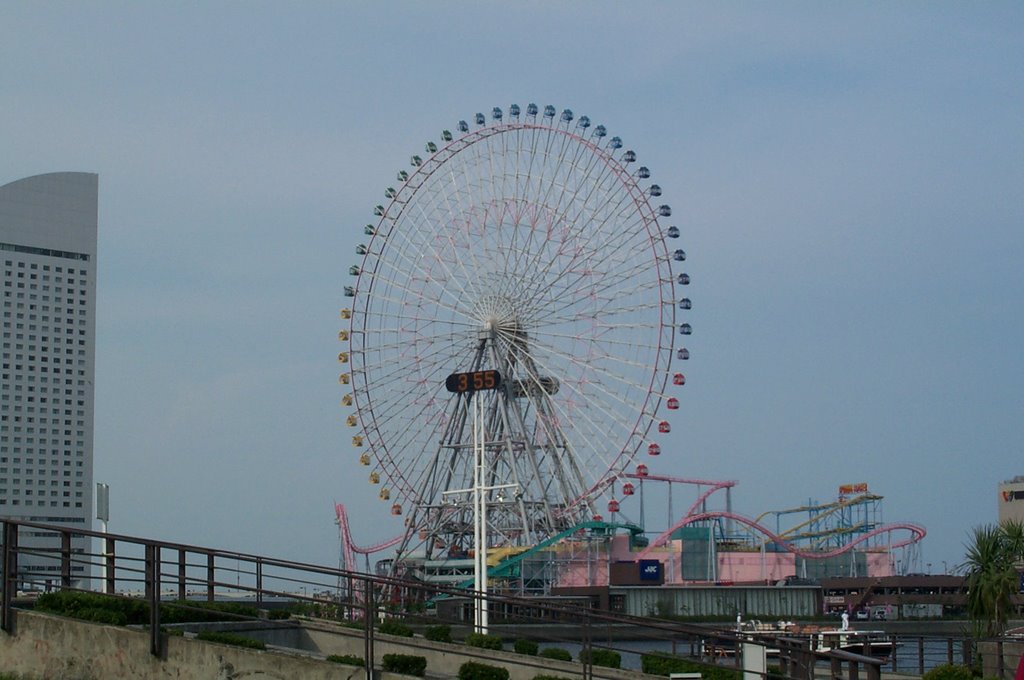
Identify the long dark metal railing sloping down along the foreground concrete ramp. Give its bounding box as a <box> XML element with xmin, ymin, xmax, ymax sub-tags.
<box><xmin>0</xmin><ymin>519</ymin><xmax>991</xmax><ymax>680</ymax></box>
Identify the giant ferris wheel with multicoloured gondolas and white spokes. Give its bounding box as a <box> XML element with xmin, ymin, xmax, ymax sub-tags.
<box><xmin>338</xmin><ymin>103</ymin><xmax>690</xmax><ymax>557</ymax></box>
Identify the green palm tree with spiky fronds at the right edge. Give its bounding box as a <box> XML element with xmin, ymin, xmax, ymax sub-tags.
<box><xmin>964</xmin><ymin>522</ymin><xmax>1024</xmax><ymax>637</ymax></box>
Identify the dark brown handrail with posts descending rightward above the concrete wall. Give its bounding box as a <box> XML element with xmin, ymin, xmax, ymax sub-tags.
<box><xmin>0</xmin><ymin>519</ymin><xmax>958</xmax><ymax>680</ymax></box>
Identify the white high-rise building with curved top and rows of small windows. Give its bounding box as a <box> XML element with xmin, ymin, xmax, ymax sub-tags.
<box><xmin>0</xmin><ymin>172</ymin><xmax>98</xmax><ymax>588</ymax></box>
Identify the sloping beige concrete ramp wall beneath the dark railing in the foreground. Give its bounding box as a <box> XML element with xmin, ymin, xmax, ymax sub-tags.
<box><xmin>0</xmin><ymin>609</ymin><xmax>652</xmax><ymax>680</ymax></box>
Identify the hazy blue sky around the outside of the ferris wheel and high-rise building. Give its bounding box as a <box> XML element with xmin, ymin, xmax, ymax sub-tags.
<box><xmin>0</xmin><ymin>0</ymin><xmax>1024</xmax><ymax>571</ymax></box>
